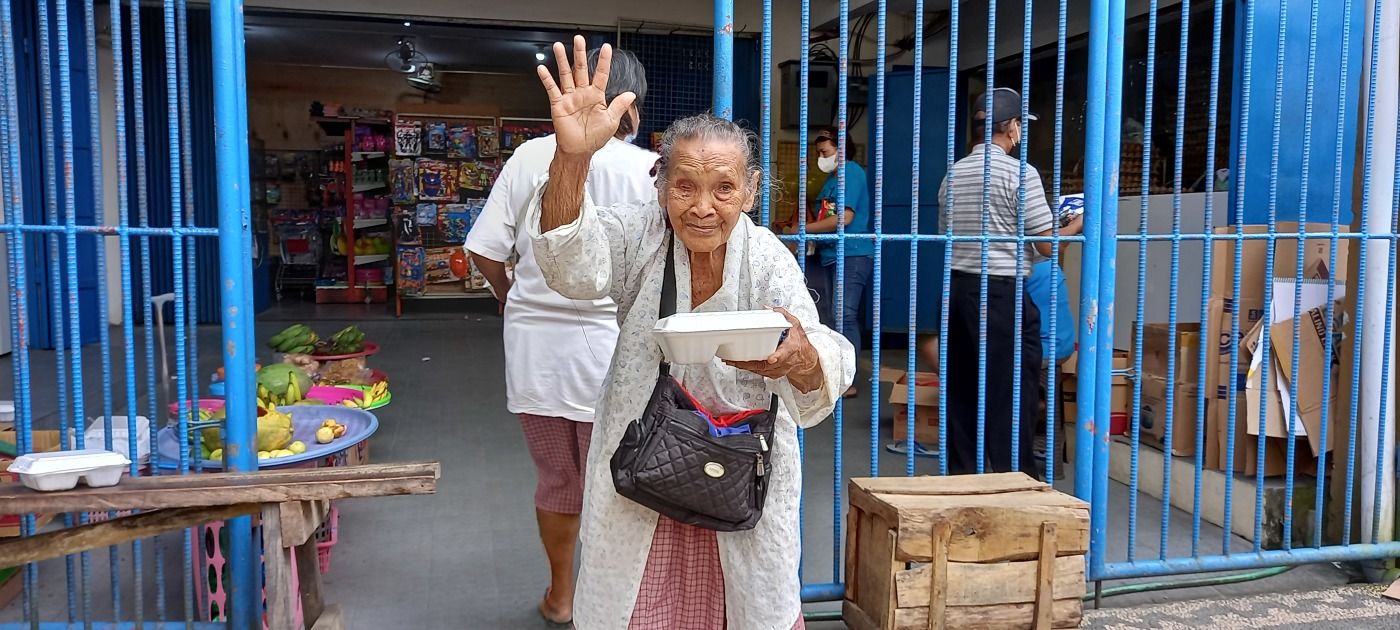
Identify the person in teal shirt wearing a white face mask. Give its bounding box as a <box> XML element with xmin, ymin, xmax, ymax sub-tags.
<box><xmin>784</xmin><ymin>127</ymin><xmax>875</xmax><ymax>398</ymax></box>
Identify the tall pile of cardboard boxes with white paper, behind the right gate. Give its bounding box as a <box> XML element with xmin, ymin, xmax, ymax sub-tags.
<box><xmin>1205</xmin><ymin>223</ymin><xmax>1348</xmax><ymax>476</ymax></box>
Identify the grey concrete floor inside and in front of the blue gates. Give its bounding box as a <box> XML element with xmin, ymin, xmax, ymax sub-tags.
<box><xmin>0</xmin><ymin>300</ymin><xmax>1383</xmax><ymax>630</ymax></box>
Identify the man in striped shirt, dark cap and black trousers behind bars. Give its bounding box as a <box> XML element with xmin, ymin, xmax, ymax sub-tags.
<box><xmin>939</xmin><ymin>88</ymin><xmax>1082</xmax><ymax>476</ymax></box>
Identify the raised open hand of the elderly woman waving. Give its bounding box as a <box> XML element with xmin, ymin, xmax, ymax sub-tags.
<box><xmin>536</xmin><ymin>35</ymin><xmax>637</xmax><ymax>155</ymax></box>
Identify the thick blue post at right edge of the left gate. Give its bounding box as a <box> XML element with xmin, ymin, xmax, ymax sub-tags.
<box><xmin>210</xmin><ymin>0</ymin><xmax>262</xmax><ymax>627</ymax></box>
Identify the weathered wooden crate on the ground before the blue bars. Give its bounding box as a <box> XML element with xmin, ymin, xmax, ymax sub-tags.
<box><xmin>843</xmin><ymin>473</ymin><xmax>1089</xmax><ymax>630</ymax></box>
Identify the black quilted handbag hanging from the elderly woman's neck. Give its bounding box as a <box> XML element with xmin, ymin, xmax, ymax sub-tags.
<box><xmin>610</xmin><ymin>236</ymin><xmax>777</xmax><ymax>532</ymax></box>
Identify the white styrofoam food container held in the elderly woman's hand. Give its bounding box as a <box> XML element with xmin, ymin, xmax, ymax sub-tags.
<box><xmin>652</xmin><ymin>311</ymin><xmax>792</xmax><ymax>365</ymax></box>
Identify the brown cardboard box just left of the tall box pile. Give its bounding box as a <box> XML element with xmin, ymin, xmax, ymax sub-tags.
<box><xmin>1138</xmin><ymin>323</ymin><xmax>1201</xmax><ymax>456</ymax></box>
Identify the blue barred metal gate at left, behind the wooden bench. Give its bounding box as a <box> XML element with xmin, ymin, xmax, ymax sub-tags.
<box><xmin>0</xmin><ymin>0</ymin><xmax>262</xmax><ymax>629</ymax></box>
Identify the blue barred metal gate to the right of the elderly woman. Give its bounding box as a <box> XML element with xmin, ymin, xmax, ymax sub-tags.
<box><xmin>714</xmin><ymin>0</ymin><xmax>1400</xmax><ymax>602</ymax></box>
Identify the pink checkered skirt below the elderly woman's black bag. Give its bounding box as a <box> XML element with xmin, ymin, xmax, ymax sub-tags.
<box><xmin>627</xmin><ymin>517</ymin><xmax>806</xmax><ymax>630</ymax></box>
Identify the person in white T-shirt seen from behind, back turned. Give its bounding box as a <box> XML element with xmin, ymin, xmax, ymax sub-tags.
<box><xmin>466</xmin><ymin>50</ymin><xmax>657</xmax><ymax>624</ymax></box>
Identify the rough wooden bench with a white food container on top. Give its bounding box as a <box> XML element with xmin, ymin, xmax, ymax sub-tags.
<box><xmin>0</xmin><ymin>462</ymin><xmax>441</xmax><ymax>630</ymax></box>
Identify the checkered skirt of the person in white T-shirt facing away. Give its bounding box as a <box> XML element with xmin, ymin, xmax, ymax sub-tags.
<box><xmin>521</xmin><ymin>413</ymin><xmax>594</xmax><ymax>514</ymax></box>
